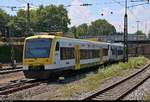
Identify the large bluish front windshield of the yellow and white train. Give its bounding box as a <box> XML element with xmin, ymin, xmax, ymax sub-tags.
<box><xmin>25</xmin><ymin>38</ymin><xmax>52</xmax><ymax>58</ymax></box>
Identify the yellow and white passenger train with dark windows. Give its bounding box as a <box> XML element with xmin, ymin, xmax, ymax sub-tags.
<box><xmin>23</xmin><ymin>32</ymin><xmax>124</xmax><ymax>79</ymax></box>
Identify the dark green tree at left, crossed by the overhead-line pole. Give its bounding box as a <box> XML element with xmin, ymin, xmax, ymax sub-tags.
<box><xmin>8</xmin><ymin>9</ymin><xmax>36</xmax><ymax>37</ymax></box>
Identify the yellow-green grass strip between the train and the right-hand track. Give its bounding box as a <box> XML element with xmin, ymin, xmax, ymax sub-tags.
<box><xmin>50</xmin><ymin>57</ymin><xmax>146</xmax><ymax>99</ymax></box>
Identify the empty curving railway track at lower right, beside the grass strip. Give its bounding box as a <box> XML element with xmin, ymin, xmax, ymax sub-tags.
<box><xmin>81</xmin><ymin>64</ymin><xmax>150</xmax><ymax>100</ymax></box>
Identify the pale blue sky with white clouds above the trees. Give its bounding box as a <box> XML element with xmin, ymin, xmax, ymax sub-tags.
<box><xmin>0</xmin><ymin>0</ymin><xmax>150</xmax><ymax>34</ymax></box>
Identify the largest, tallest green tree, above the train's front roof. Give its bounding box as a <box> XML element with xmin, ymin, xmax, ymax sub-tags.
<box><xmin>36</xmin><ymin>5</ymin><xmax>70</xmax><ymax>32</ymax></box>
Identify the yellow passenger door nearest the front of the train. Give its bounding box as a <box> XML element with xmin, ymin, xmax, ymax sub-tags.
<box><xmin>75</xmin><ymin>45</ymin><xmax>80</xmax><ymax>70</ymax></box>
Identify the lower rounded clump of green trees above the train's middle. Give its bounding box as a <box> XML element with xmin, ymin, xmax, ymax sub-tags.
<box><xmin>70</xmin><ymin>19</ymin><xmax>116</xmax><ymax>37</ymax></box>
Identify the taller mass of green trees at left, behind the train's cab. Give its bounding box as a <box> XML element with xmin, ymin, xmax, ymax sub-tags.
<box><xmin>3</xmin><ymin>5</ymin><xmax>70</xmax><ymax>36</ymax></box>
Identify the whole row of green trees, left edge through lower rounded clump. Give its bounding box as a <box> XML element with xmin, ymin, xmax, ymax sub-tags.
<box><xmin>0</xmin><ymin>5</ymin><xmax>116</xmax><ymax>38</ymax></box>
